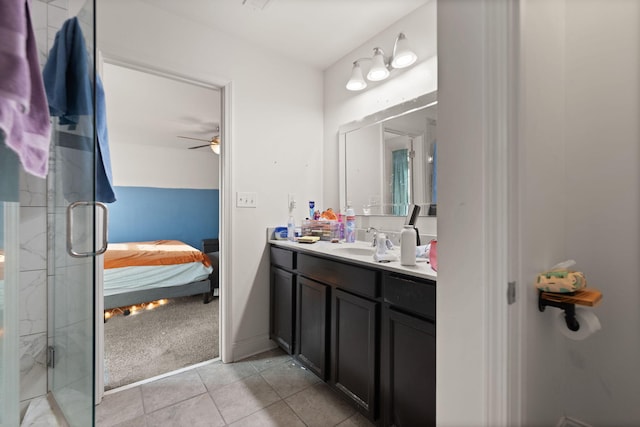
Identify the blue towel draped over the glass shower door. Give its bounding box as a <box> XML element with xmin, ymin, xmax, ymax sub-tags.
<box><xmin>43</xmin><ymin>17</ymin><xmax>116</xmax><ymax>203</ymax></box>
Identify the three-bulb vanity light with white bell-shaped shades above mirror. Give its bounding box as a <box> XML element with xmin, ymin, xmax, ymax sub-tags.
<box><xmin>347</xmin><ymin>33</ymin><xmax>418</xmax><ymax>91</ymax></box>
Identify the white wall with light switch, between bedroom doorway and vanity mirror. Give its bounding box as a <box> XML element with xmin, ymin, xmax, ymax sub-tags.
<box><xmin>97</xmin><ymin>0</ymin><xmax>322</xmax><ymax>359</ymax></box>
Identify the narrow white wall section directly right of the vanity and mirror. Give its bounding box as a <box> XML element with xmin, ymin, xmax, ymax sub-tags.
<box><xmin>436</xmin><ymin>0</ymin><xmax>493</xmax><ymax>427</ymax></box>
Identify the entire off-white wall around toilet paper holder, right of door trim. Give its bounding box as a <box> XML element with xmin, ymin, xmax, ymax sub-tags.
<box><xmin>521</xmin><ymin>0</ymin><xmax>640</xmax><ymax>426</ymax></box>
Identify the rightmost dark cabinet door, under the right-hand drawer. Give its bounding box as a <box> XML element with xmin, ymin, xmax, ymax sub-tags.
<box><xmin>382</xmin><ymin>307</ymin><xmax>436</xmax><ymax>427</ymax></box>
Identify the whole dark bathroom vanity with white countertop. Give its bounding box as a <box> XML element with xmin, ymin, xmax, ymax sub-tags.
<box><xmin>269</xmin><ymin>240</ymin><xmax>436</xmax><ymax>427</ymax></box>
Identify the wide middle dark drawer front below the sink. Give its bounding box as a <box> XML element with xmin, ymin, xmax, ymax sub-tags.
<box><xmin>298</xmin><ymin>254</ymin><xmax>380</xmax><ymax>298</ymax></box>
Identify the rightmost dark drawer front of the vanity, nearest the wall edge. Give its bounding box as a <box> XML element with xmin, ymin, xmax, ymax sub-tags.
<box><xmin>382</xmin><ymin>274</ymin><xmax>436</xmax><ymax>320</ymax></box>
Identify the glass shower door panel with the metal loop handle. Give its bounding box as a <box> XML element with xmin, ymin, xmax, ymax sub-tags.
<box><xmin>45</xmin><ymin>0</ymin><xmax>106</xmax><ymax>426</ymax></box>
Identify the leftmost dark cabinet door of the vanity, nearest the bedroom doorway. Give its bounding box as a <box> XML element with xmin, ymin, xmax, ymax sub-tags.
<box><xmin>269</xmin><ymin>267</ymin><xmax>296</xmax><ymax>354</ymax></box>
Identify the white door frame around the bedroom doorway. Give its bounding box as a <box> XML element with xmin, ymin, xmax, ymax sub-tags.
<box><xmin>94</xmin><ymin>50</ymin><xmax>233</xmax><ymax>405</ymax></box>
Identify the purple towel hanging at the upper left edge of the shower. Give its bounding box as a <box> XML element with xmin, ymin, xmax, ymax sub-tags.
<box><xmin>0</xmin><ymin>0</ymin><xmax>51</xmax><ymax>178</ymax></box>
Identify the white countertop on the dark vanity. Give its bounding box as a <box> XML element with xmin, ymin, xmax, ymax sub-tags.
<box><xmin>268</xmin><ymin>239</ymin><xmax>438</xmax><ymax>281</ymax></box>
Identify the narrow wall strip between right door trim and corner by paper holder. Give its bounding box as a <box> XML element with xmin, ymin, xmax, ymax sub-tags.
<box><xmin>518</xmin><ymin>0</ymin><xmax>567</xmax><ymax>426</ymax></box>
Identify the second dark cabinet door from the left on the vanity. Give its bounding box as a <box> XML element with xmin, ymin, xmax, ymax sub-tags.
<box><xmin>296</xmin><ymin>276</ymin><xmax>329</xmax><ymax>380</ymax></box>
